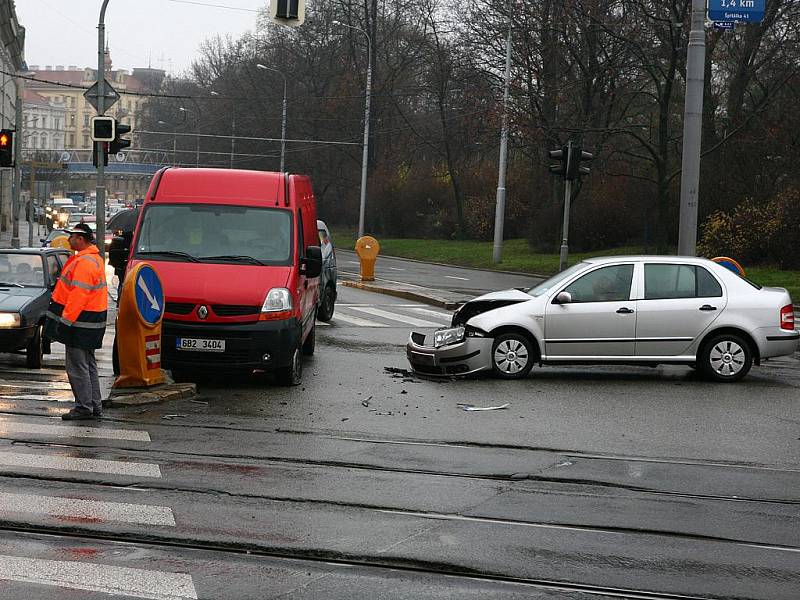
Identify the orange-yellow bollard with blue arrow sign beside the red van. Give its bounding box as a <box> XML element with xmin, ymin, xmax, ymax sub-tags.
<box><xmin>112</xmin><ymin>263</ymin><xmax>164</xmax><ymax>389</ymax></box>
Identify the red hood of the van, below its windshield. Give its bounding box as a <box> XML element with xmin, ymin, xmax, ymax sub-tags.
<box><xmin>131</xmin><ymin>260</ymin><xmax>292</xmax><ymax>306</ymax></box>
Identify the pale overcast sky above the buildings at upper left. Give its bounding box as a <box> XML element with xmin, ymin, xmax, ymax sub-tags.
<box><xmin>15</xmin><ymin>0</ymin><xmax>269</xmax><ymax>74</ymax></box>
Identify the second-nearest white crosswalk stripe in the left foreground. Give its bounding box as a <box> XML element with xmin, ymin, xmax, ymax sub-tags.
<box><xmin>0</xmin><ymin>492</ymin><xmax>175</xmax><ymax>527</ymax></box>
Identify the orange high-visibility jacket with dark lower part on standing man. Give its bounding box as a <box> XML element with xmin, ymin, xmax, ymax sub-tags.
<box><xmin>44</xmin><ymin>245</ymin><xmax>108</xmax><ymax>349</ymax></box>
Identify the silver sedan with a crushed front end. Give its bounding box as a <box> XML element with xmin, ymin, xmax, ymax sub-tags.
<box><xmin>406</xmin><ymin>256</ymin><xmax>800</xmax><ymax>382</ymax></box>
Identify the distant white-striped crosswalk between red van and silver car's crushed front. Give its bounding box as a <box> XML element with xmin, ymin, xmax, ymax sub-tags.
<box><xmin>317</xmin><ymin>303</ymin><xmax>453</xmax><ymax>329</ymax></box>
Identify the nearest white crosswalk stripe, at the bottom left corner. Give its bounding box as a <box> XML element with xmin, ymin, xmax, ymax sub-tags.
<box><xmin>0</xmin><ymin>556</ymin><xmax>197</xmax><ymax>600</ymax></box>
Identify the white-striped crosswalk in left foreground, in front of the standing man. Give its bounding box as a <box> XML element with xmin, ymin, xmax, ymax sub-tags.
<box><xmin>0</xmin><ymin>415</ymin><xmax>198</xmax><ymax>600</ymax></box>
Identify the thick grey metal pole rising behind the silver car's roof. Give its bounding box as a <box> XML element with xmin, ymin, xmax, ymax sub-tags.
<box><xmin>678</xmin><ymin>0</ymin><xmax>706</xmax><ymax>256</ymax></box>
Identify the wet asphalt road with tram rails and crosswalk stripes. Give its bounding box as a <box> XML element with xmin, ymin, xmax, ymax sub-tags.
<box><xmin>0</xmin><ymin>284</ymin><xmax>800</xmax><ymax>600</ymax></box>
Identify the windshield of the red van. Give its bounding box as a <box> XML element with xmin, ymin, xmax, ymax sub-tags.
<box><xmin>134</xmin><ymin>204</ymin><xmax>292</xmax><ymax>265</ymax></box>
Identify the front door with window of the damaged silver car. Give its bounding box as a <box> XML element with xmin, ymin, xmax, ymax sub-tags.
<box><xmin>545</xmin><ymin>263</ymin><xmax>636</xmax><ymax>360</ymax></box>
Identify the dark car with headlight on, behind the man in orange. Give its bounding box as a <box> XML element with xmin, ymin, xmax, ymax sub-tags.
<box><xmin>0</xmin><ymin>248</ymin><xmax>70</xmax><ymax>369</ymax></box>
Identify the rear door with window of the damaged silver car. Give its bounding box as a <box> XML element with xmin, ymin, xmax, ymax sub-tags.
<box><xmin>636</xmin><ymin>263</ymin><xmax>727</xmax><ymax>357</ymax></box>
